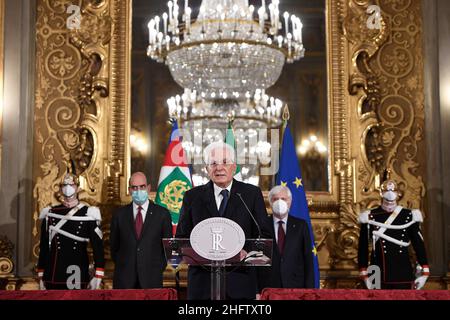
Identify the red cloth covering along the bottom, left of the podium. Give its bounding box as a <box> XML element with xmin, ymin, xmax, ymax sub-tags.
<box><xmin>0</xmin><ymin>288</ymin><xmax>177</xmax><ymax>300</ymax></box>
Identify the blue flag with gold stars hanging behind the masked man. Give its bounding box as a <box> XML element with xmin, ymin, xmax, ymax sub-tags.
<box><xmin>276</xmin><ymin>125</ymin><xmax>320</xmax><ymax>288</ymax></box>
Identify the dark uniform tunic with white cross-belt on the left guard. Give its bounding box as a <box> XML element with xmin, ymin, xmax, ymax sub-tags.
<box><xmin>38</xmin><ymin>205</ymin><xmax>105</xmax><ymax>289</ymax></box>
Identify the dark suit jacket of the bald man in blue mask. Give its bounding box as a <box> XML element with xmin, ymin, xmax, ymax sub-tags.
<box><xmin>110</xmin><ymin>201</ymin><xmax>172</xmax><ymax>289</ymax></box>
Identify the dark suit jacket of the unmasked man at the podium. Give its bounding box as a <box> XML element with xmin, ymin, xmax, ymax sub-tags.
<box><xmin>176</xmin><ymin>180</ymin><xmax>272</xmax><ymax>300</ymax></box>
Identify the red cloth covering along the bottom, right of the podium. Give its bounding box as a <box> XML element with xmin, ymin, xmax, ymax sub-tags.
<box><xmin>261</xmin><ymin>288</ymin><xmax>450</xmax><ymax>300</ymax></box>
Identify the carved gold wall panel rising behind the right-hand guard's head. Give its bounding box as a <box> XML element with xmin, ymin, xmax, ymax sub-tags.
<box><xmin>349</xmin><ymin>0</ymin><xmax>426</xmax><ymax>208</ymax></box>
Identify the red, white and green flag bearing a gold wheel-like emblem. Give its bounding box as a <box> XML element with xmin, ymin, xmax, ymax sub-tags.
<box><xmin>155</xmin><ymin>120</ymin><xmax>192</xmax><ymax>234</ymax></box>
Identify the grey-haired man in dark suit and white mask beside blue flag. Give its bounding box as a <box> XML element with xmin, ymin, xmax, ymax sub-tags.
<box><xmin>258</xmin><ymin>186</ymin><xmax>314</xmax><ymax>290</ymax></box>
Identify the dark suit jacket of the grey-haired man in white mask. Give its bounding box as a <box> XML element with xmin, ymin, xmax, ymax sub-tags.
<box><xmin>258</xmin><ymin>215</ymin><xmax>314</xmax><ymax>290</ymax></box>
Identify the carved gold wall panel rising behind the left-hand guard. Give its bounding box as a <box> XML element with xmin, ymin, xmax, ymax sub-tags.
<box><xmin>32</xmin><ymin>0</ymin><xmax>130</xmax><ymax>256</ymax></box>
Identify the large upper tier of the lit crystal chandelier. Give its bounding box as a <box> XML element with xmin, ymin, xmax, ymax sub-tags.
<box><xmin>147</xmin><ymin>0</ymin><xmax>304</xmax><ymax>100</ymax></box>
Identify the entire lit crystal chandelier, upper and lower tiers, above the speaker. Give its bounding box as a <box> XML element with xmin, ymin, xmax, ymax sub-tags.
<box><xmin>147</xmin><ymin>0</ymin><xmax>305</xmax><ymax>185</ymax></box>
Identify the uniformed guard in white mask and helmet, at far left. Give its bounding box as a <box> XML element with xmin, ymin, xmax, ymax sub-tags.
<box><xmin>37</xmin><ymin>173</ymin><xmax>105</xmax><ymax>290</ymax></box>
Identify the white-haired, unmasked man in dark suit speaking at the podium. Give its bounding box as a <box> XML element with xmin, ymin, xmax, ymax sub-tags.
<box><xmin>176</xmin><ymin>142</ymin><xmax>272</xmax><ymax>300</ymax></box>
